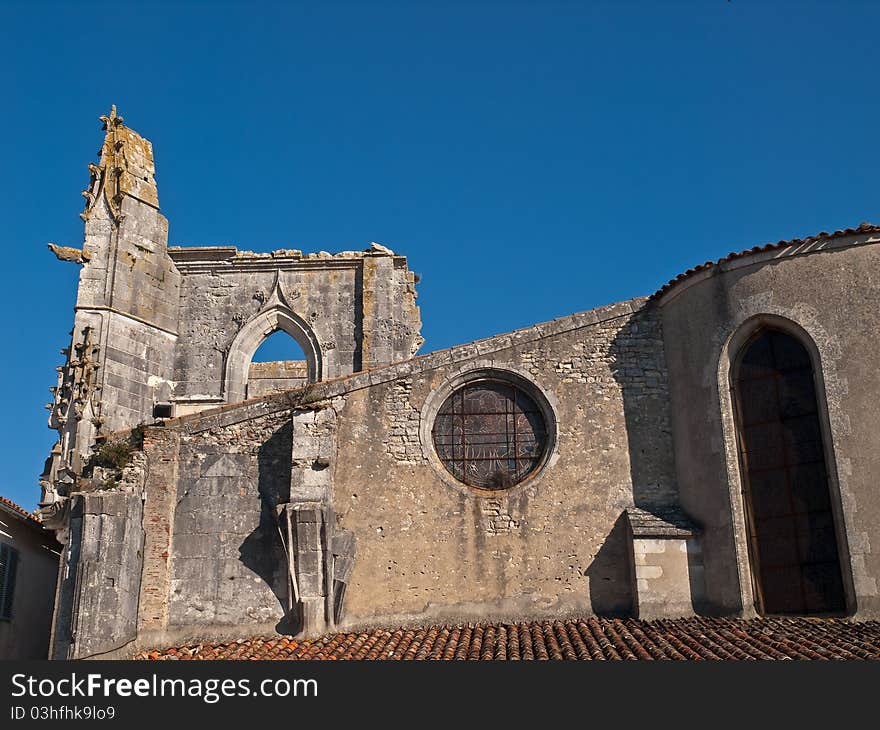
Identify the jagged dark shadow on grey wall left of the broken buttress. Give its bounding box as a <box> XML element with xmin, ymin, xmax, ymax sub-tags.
<box><xmin>238</xmin><ymin>421</ymin><xmax>295</xmax><ymax>634</ymax></box>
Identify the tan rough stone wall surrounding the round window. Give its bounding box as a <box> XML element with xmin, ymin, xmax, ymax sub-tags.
<box><xmin>333</xmin><ymin>304</ymin><xmax>675</xmax><ymax>626</ymax></box>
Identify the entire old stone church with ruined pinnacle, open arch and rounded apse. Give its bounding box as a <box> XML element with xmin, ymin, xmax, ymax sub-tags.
<box><xmin>41</xmin><ymin>108</ymin><xmax>880</xmax><ymax>658</ymax></box>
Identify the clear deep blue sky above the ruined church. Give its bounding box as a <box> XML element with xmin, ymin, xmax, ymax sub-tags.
<box><xmin>0</xmin><ymin>0</ymin><xmax>880</xmax><ymax>508</ymax></box>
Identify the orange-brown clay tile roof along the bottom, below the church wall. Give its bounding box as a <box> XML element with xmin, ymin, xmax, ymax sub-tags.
<box><xmin>135</xmin><ymin>617</ymin><xmax>880</xmax><ymax>660</ymax></box>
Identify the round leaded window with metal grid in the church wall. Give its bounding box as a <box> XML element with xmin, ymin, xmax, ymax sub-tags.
<box><xmin>432</xmin><ymin>380</ymin><xmax>548</xmax><ymax>490</ymax></box>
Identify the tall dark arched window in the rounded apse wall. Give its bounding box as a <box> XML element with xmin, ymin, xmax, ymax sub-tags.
<box><xmin>734</xmin><ymin>329</ymin><xmax>846</xmax><ymax>614</ymax></box>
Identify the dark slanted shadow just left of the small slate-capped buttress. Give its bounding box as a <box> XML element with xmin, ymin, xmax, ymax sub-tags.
<box><xmin>586</xmin><ymin>515</ymin><xmax>635</xmax><ymax>616</ymax></box>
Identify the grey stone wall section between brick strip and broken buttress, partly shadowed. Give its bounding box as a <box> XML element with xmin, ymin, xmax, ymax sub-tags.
<box><xmin>168</xmin><ymin>412</ymin><xmax>292</xmax><ymax>630</ymax></box>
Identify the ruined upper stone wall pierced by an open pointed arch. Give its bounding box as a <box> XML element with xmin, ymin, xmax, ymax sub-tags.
<box><xmin>171</xmin><ymin>247</ymin><xmax>422</xmax><ymax>413</ymax></box>
